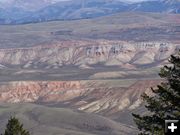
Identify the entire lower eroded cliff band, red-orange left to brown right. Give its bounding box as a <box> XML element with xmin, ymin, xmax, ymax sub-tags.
<box><xmin>0</xmin><ymin>80</ymin><xmax>161</xmax><ymax>115</ymax></box>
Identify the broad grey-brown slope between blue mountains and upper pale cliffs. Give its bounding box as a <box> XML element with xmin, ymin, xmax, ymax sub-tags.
<box><xmin>0</xmin><ymin>12</ymin><xmax>180</xmax><ymax>48</ymax></box>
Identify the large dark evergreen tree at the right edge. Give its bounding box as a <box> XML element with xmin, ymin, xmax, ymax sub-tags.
<box><xmin>133</xmin><ymin>52</ymin><xmax>180</xmax><ymax>135</ymax></box>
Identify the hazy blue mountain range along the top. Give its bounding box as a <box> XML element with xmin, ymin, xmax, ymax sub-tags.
<box><xmin>0</xmin><ymin>0</ymin><xmax>180</xmax><ymax>24</ymax></box>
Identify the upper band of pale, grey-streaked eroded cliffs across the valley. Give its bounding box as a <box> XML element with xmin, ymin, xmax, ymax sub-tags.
<box><xmin>0</xmin><ymin>40</ymin><xmax>180</xmax><ymax>68</ymax></box>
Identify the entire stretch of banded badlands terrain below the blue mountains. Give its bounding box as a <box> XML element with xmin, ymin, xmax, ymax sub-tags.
<box><xmin>0</xmin><ymin>12</ymin><xmax>180</xmax><ymax>135</ymax></box>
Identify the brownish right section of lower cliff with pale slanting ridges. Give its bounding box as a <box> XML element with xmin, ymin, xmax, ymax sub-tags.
<box><xmin>75</xmin><ymin>80</ymin><xmax>161</xmax><ymax>114</ymax></box>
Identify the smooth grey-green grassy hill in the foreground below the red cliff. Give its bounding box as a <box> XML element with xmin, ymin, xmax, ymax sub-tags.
<box><xmin>0</xmin><ymin>103</ymin><xmax>135</xmax><ymax>135</ymax></box>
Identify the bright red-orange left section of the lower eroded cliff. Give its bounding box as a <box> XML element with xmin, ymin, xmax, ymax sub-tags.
<box><xmin>0</xmin><ymin>81</ymin><xmax>83</xmax><ymax>103</ymax></box>
